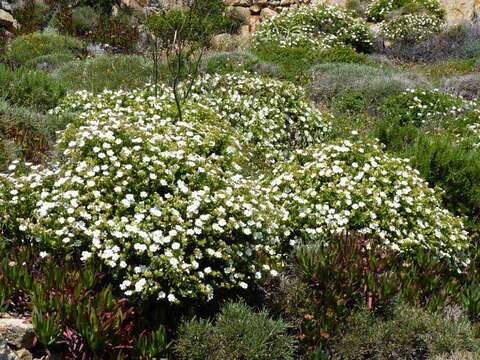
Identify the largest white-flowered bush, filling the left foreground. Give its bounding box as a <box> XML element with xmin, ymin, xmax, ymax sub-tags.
<box><xmin>0</xmin><ymin>84</ymin><xmax>279</xmax><ymax>302</ymax></box>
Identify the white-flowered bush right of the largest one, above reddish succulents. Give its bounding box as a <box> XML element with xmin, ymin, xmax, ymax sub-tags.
<box><xmin>269</xmin><ymin>140</ymin><xmax>468</xmax><ymax>269</ymax></box>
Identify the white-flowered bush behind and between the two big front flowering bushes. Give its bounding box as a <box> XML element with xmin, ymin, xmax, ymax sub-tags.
<box><xmin>189</xmin><ymin>73</ymin><xmax>332</xmax><ymax>159</ymax></box>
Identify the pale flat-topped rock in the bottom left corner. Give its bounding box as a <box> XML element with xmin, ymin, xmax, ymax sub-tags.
<box><xmin>0</xmin><ymin>319</ymin><xmax>35</xmax><ymax>349</ymax></box>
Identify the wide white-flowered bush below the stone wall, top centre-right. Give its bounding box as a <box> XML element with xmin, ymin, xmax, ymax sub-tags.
<box><xmin>253</xmin><ymin>4</ymin><xmax>372</xmax><ymax>51</ymax></box>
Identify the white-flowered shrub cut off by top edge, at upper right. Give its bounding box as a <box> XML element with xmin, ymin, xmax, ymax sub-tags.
<box><xmin>367</xmin><ymin>0</ymin><xmax>445</xmax><ymax>22</ymax></box>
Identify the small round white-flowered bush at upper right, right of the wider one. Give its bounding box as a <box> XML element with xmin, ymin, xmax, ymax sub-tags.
<box><xmin>380</xmin><ymin>14</ymin><xmax>444</xmax><ymax>43</ymax></box>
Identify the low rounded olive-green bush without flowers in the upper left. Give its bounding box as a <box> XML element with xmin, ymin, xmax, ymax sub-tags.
<box><xmin>5</xmin><ymin>32</ymin><xmax>84</xmax><ymax>64</ymax></box>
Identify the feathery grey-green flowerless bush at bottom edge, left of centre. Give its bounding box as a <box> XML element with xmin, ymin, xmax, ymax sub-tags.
<box><xmin>175</xmin><ymin>303</ymin><xmax>295</xmax><ymax>360</ymax></box>
